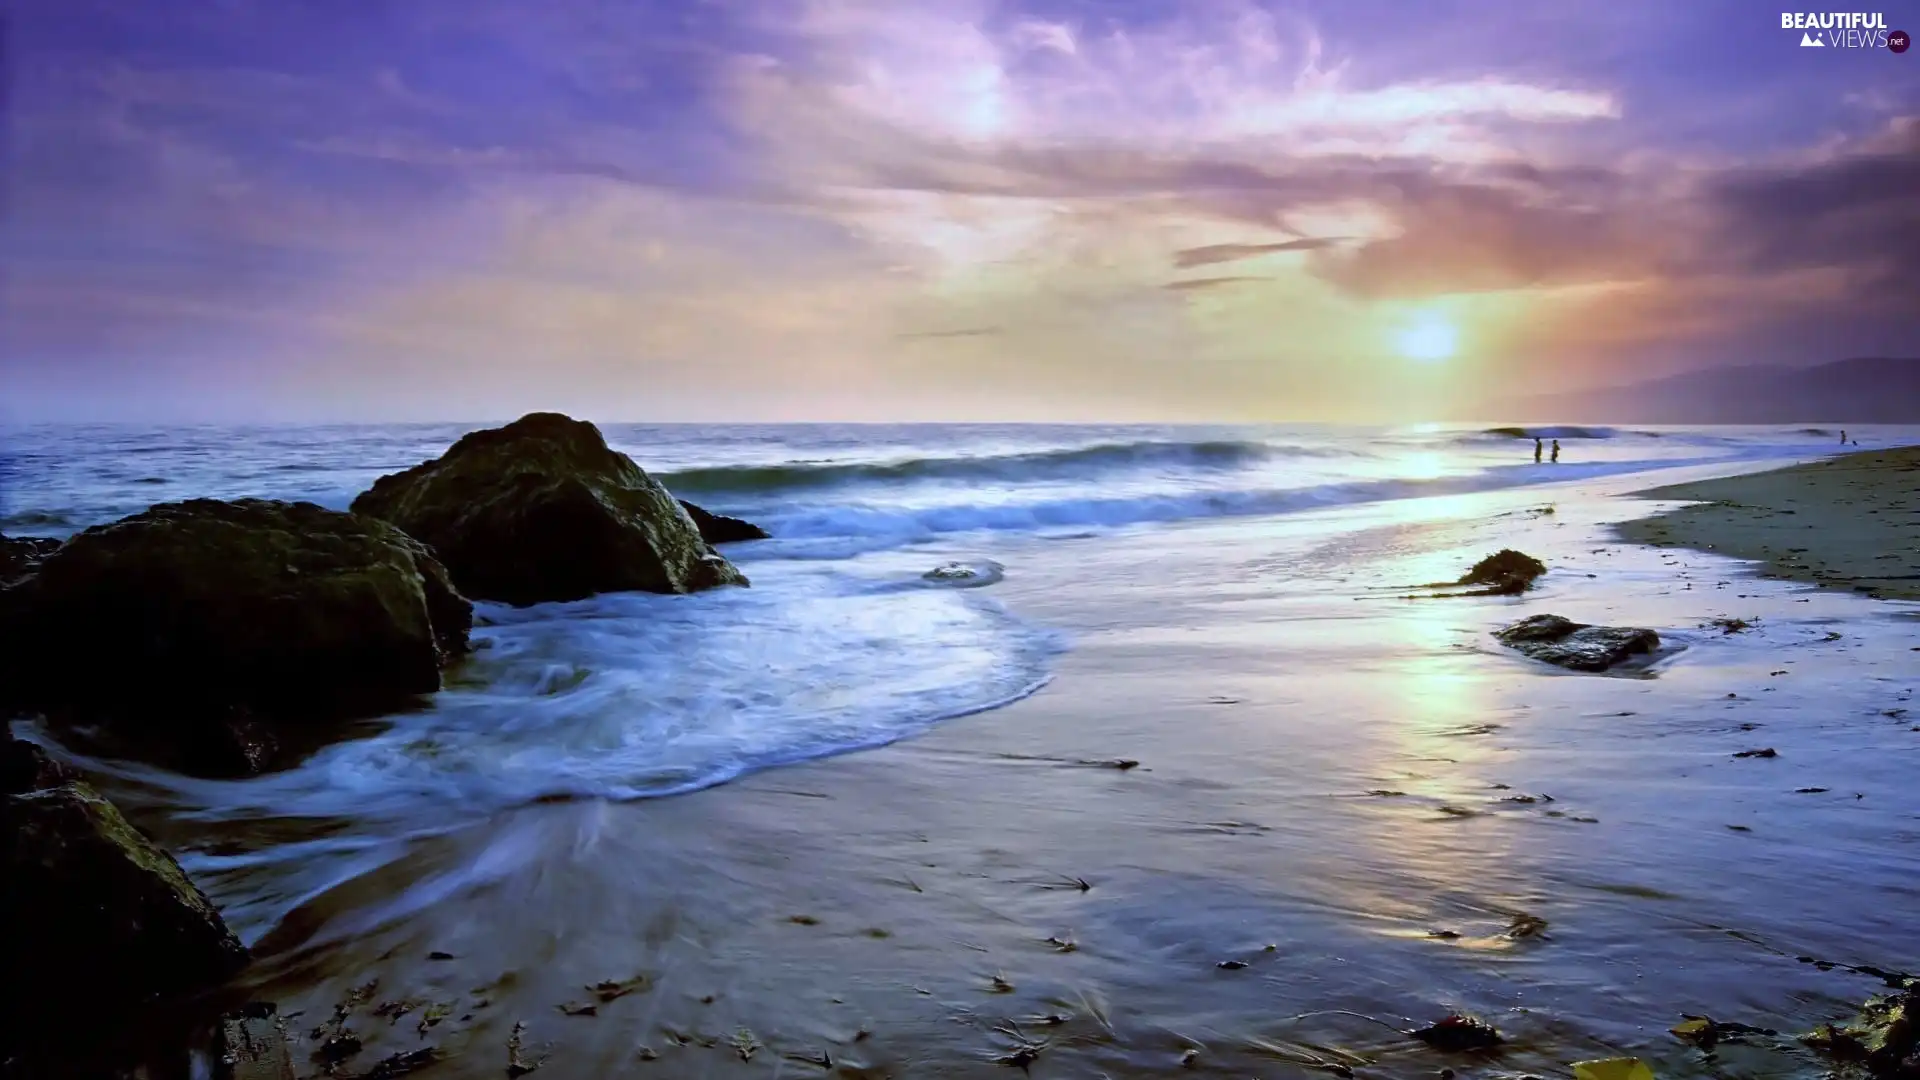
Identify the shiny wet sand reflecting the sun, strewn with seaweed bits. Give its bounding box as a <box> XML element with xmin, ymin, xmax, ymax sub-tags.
<box><xmin>52</xmin><ymin>463</ymin><xmax>1920</xmax><ymax>1080</ymax></box>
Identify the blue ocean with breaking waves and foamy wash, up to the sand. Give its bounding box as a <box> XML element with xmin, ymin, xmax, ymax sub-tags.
<box><xmin>0</xmin><ymin>425</ymin><xmax>1864</xmax><ymax>815</ymax></box>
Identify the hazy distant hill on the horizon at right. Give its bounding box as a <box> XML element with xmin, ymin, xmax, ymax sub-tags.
<box><xmin>1500</xmin><ymin>357</ymin><xmax>1920</xmax><ymax>425</ymax></box>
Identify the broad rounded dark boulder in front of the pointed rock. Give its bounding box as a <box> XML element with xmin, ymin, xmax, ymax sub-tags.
<box><xmin>0</xmin><ymin>500</ymin><xmax>472</xmax><ymax>767</ymax></box>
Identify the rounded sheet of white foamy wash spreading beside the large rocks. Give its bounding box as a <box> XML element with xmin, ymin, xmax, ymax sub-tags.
<box><xmin>163</xmin><ymin>563</ymin><xmax>1052</xmax><ymax>821</ymax></box>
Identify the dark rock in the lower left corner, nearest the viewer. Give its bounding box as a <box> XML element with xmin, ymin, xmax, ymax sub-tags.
<box><xmin>0</xmin><ymin>782</ymin><xmax>248</xmax><ymax>1032</ymax></box>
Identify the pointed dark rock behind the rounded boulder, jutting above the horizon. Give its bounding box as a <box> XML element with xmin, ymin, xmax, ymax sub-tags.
<box><xmin>353</xmin><ymin>413</ymin><xmax>747</xmax><ymax>605</ymax></box>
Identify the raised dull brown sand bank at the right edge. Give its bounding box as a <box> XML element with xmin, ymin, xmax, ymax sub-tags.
<box><xmin>1620</xmin><ymin>446</ymin><xmax>1920</xmax><ymax>600</ymax></box>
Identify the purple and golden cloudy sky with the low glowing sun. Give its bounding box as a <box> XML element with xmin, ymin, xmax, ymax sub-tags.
<box><xmin>0</xmin><ymin>0</ymin><xmax>1920</xmax><ymax>423</ymax></box>
